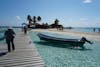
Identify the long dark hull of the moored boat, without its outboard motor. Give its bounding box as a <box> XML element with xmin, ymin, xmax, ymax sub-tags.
<box><xmin>38</xmin><ymin>33</ymin><xmax>85</xmax><ymax>47</ymax></box>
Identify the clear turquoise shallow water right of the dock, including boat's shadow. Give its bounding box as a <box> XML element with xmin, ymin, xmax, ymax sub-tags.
<box><xmin>30</xmin><ymin>32</ymin><xmax>100</xmax><ymax>67</ymax></box>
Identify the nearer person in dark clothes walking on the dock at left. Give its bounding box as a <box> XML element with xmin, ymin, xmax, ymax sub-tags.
<box><xmin>4</xmin><ymin>27</ymin><xmax>15</xmax><ymax>52</ymax></box>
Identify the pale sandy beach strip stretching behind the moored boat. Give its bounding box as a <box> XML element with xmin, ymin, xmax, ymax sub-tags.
<box><xmin>32</xmin><ymin>29</ymin><xmax>100</xmax><ymax>41</ymax></box>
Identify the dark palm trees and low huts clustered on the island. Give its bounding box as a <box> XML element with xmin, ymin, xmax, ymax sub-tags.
<box><xmin>27</xmin><ymin>15</ymin><xmax>63</xmax><ymax>29</ymax></box>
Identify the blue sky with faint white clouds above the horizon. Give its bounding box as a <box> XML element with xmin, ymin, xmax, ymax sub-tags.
<box><xmin>0</xmin><ymin>0</ymin><xmax>100</xmax><ymax>27</ymax></box>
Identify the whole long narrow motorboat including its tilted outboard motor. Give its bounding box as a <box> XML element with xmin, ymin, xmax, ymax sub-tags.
<box><xmin>37</xmin><ymin>33</ymin><xmax>92</xmax><ymax>48</ymax></box>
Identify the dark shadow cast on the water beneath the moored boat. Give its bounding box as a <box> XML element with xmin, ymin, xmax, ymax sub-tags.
<box><xmin>34</xmin><ymin>41</ymin><xmax>92</xmax><ymax>51</ymax></box>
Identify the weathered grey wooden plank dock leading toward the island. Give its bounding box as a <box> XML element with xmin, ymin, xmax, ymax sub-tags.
<box><xmin>0</xmin><ymin>32</ymin><xmax>46</xmax><ymax>67</ymax></box>
